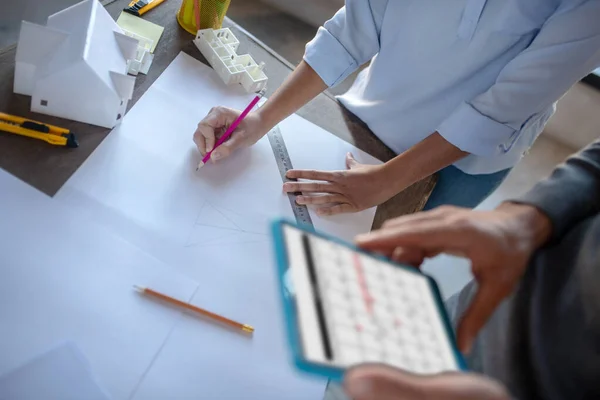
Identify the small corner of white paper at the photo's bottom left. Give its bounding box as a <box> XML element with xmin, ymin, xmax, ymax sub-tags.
<box><xmin>0</xmin><ymin>342</ymin><xmax>110</xmax><ymax>400</ymax></box>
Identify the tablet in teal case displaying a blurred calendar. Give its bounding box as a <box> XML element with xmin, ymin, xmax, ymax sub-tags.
<box><xmin>272</xmin><ymin>220</ymin><xmax>466</xmax><ymax>381</ymax></box>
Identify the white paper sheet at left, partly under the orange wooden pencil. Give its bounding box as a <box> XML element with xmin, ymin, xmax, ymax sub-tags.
<box><xmin>0</xmin><ymin>170</ymin><xmax>198</xmax><ymax>399</ymax></box>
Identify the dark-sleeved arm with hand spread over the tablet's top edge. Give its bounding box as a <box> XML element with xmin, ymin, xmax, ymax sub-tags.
<box><xmin>357</xmin><ymin>140</ymin><xmax>600</xmax><ymax>349</ymax></box>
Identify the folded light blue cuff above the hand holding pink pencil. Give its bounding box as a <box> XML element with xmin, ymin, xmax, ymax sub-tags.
<box><xmin>304</xmin><ymin>27</ymin><xmax>358</xmax><ymax>87</ymax></box>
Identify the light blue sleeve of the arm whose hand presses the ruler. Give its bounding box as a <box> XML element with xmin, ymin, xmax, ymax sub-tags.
<box><xmin>438</xmin><ymin>0</ymin><xmax>600</xmax><ymax>156</ymax></box>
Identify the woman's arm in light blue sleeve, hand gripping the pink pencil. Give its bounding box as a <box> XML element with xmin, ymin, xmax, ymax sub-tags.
<box><xmin>194</xmin><ymin>0</ymin><xmax>388</xmax><ymax>161</ymax></box>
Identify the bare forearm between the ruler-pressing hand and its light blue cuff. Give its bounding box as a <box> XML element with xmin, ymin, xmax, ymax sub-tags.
<box><xmin>383</xmin><ymin>132</ymin><xmax>469</xmax><ymax>193</ymax></box>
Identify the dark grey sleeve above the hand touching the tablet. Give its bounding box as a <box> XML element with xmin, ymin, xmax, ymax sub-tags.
<box><xmin>511</xmin><ymin>140</ymin><xmax>600</xmax><ymax>239</ymax></box>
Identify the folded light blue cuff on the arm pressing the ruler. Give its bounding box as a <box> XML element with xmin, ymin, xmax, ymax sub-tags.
<box><xmin>437</xmin><ymin>103</ymin><xmax>516</xmax><ymax>157</ymax></box>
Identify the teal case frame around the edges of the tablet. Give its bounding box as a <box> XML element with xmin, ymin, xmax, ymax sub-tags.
<box><xmin>271</xmin><ymin>219</ymin><xmax>467</xmax><ymax>382</ymax></box>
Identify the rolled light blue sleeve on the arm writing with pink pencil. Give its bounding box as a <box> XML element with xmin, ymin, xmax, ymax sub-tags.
<box><xmin>304</xmin><ymin>0</ymin><xmax>388</xmax><ymax>87</ymax></box>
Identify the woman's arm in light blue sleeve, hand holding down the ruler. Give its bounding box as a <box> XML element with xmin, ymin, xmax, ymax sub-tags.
<box><xmin>286</xmin><ymin>1</ymin><xmax>600</xmax><ymax>213</ymax></box>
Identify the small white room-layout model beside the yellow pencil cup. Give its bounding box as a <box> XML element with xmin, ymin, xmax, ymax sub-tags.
<box><xmin>194</xmin><ymin>28</ymin><xmax>268</xmax><ymax>93</ymax></box>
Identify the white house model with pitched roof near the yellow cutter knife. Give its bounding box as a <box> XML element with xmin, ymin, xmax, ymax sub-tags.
<box><xmin>14</xmin><ymin>0</ymin><xmax>138</xmax><ymax>128</ymax></box>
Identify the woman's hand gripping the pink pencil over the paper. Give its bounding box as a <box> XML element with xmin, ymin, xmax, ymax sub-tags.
<box><xmin>194</xmin><ymin>107</ymin><xmax>269</xmax><ymax>161</ymax></box>
